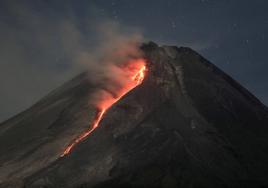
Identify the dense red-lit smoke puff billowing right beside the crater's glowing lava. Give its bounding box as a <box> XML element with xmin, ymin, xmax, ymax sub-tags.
<box><xmin>76</xmin><ymin>20</ymin><xmax>143</xmax><ymax>108</ymax></box>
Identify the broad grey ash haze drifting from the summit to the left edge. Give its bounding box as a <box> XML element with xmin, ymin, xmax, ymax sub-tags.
<box><xmin>0</xmin><ymin>1</ymin><xmax>142</xmax><ymax>122</ymax></box>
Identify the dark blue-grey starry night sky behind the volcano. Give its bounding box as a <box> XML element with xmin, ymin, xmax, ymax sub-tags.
<box><xmin>0</xmin><ymin>0</ymin><xmax>268</xmax><ymax>122</ymax></box>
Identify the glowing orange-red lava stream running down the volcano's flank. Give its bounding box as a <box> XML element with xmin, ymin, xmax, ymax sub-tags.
<box><xmin>61</xmin><ymin>59</ymin><xmax>146</xmax><ymax>157</ymax></box>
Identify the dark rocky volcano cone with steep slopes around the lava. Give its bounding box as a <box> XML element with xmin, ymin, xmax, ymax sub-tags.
<box><xmin>0</xmin><ymin>42</ymin><xmax>268</xmax><ymax>188</ymax></box>
